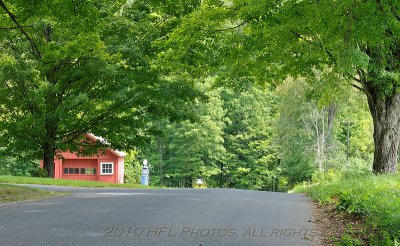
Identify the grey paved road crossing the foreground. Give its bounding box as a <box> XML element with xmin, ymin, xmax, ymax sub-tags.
<box><xmin>0</xmin><ymin>186</ymin><xmax>317</xmax><ymax>246</ymax></box>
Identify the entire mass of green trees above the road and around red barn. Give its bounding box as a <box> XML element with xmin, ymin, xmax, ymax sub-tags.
<box><xmin>0</xmin><ymin>0</ymin><xmax>400</xmax><ymax>190</ymax></box>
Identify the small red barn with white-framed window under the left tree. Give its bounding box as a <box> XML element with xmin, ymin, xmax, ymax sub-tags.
<box><xmin>40</xmin><ymin>134</ymin><xmax>126</xmax><ymax>183</ymax></box>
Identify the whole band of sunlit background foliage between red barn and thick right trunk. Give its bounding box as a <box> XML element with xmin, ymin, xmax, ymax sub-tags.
<box><xmin>136</xmin><ymin>61</ymin><xmax>373</xmax><ymax>190</ymax></box>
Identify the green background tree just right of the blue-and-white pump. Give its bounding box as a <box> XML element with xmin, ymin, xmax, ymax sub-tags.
<box><xmin>143</xmin><ymin>86</ymin><xmax>226</xmax><ymax>187</ymax></box>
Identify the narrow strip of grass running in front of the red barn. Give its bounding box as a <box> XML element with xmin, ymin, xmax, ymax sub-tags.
<box><xmin>0</xmin><ymin>175</ymin><xmax>159</xmax><ymax>189</ymax></box>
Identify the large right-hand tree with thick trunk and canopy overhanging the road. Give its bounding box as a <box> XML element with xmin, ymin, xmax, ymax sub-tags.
<box><xmin>158</xmin><ymin>0</ymin><xmax>400</xmax><ymax>173</ymax></box>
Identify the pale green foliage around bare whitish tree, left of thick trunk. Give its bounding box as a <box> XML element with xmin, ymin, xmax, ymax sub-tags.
<box><xmin>274</xmin><ymin>78</ymin><xmax>373</xmax><ymax>188</ymax></box>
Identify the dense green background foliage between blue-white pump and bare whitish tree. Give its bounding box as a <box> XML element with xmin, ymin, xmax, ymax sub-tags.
<box><xmin>141</xmin><ymin>78</ymin><xmax>287</xmax><ymax>190</ymax></box>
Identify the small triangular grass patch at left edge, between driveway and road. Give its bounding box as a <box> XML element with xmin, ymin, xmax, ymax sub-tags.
<box><xmin>0</xmin><ymin>184</ymin><xmax>67</xmax><ymax>204</ymax></box>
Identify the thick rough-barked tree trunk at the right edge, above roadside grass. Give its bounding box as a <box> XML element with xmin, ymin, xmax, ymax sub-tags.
<box><xmin>368</xmin><ymin>93</ymin><xmax>400</xmax><ymax>173</ymax></box>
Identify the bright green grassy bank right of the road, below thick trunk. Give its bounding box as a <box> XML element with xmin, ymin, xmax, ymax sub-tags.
<box><xmin>294</xmin><ymin>175</ymin><xmax>400</xmax><ymax>245</ymax></box>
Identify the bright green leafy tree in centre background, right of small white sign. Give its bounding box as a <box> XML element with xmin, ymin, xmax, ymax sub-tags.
<box><xmin>222</xmin><ymin>81</ymin><xmax>280</xmax><ymax>190</ymax></box>
